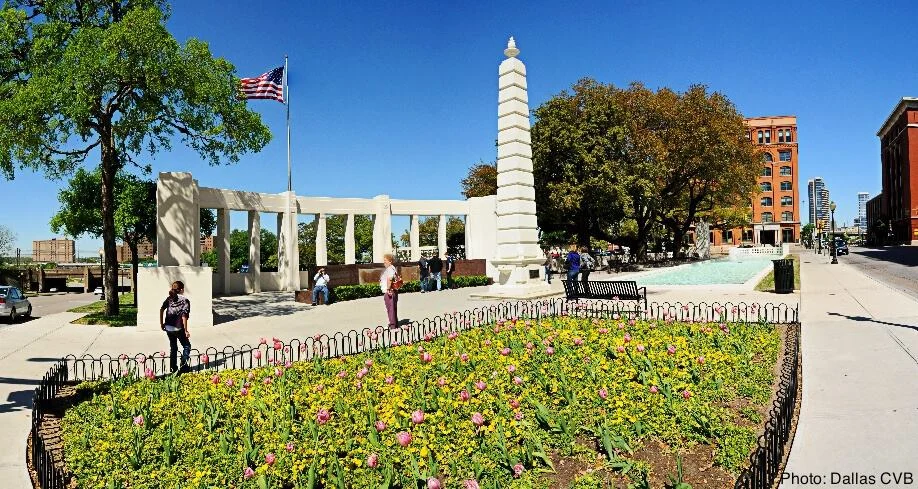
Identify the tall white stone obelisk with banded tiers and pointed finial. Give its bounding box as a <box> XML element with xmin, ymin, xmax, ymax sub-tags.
<box><xmin>478</xmin><ymin>37</ymin><xmax>553</xmax><ymax>299</ymax></box>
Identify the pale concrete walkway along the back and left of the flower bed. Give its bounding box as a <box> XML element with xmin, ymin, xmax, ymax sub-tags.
<box><xmin>0</xmin><ymin>280</ymin><xmax>799</xmax><ymax>489</ymax></box>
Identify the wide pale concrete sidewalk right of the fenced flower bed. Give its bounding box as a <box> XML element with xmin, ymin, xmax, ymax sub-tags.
<box><xmin>781</xmin><ymin>253</ymin><xmax>918</xmax><ymax>488</ymax></box>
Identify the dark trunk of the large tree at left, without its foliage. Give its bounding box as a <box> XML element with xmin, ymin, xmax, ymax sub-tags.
<box><xmin>101</xmin><ymin>125</ymin><xmax>118</xmax><ymax>316</ymax></box>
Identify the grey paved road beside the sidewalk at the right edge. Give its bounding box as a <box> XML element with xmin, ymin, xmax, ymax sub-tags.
<box><xmin>838</xmin><ymin>246</ymin><xmax>918</xmax><ymax>299</ymax></box>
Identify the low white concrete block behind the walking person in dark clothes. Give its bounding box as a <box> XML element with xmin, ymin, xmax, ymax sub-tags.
<box><xmin>137</xmin><ymin>266</ymin><xmax>214</xmax><ymax>331</ymax></box>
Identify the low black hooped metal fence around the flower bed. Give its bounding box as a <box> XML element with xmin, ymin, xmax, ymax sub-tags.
<box><xmin>31</xmin><ymin>298</ymin><xmax>799</xmax><ymax>489</ymax></box>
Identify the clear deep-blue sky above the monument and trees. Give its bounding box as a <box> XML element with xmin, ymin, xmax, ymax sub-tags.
<box><xmin>0</xmin><ymin>0</ymin><xmax>918</xmax><ymax>255</ymax></box>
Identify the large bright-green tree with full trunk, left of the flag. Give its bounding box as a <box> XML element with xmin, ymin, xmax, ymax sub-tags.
<box><xmin>0</xmin><ymin>0</ymin><xmax>270</xmax><ymax>314</ymax></box>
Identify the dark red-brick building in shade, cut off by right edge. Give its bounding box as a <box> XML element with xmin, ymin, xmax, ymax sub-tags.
<box><xmin>871</xmin><ymin>97</ymin><xmax>918</xmax><ymax>244</ymax></box>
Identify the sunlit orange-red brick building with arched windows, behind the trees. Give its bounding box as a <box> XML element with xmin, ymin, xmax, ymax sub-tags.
<box><xmin>710</xmin><ymin>115</ymin><xmax>800</xmax><ymax>245</ymax></box>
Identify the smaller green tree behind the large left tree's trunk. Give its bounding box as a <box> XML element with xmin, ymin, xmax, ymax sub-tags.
<box><xmin>50</xmin><ymin>168</ymin><xmax>216</xmax><ymax>306</ymax></box>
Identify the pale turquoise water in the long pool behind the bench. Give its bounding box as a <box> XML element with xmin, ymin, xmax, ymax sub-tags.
<box><xmin>635</xmin><ymin>258</ymin><xmax>772</xmax><ymax>285</ymax></box>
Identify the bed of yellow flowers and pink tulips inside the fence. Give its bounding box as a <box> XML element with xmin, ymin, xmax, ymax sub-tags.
<box><xmin>62</xmin><ymin>317</ymin><xmax>781</xmax><ymax>488</ymax></box>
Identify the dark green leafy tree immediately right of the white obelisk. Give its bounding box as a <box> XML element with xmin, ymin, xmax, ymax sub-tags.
<box><xmin>532</xmin><ymin>79</ymin><xmax>627</xmax><ymax>246</ymax></box>
